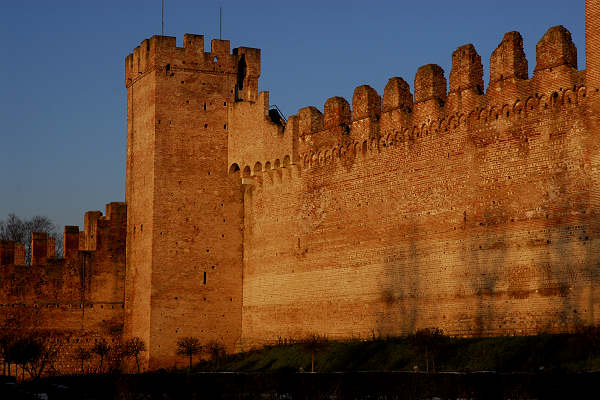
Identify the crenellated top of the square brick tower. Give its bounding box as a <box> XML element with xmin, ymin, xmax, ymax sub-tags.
<box><xmin>125</xmin><ymin>33</ymin><xmax>260</xmax><ymax>87</ymax></box>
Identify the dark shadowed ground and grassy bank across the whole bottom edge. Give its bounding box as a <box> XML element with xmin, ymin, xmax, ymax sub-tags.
<box><xmin>0</xmin><ymin>328</ymin><xmax>600</xmax><ymax>400</ymax></box>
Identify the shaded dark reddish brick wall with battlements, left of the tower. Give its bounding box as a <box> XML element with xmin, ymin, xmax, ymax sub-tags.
<box><xmin>0</xmin><ymin>203</ymin><xmax>127</xmax><ymax>373</ymax></box>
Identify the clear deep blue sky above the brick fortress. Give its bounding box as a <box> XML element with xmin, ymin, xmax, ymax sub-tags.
<box><xmin>0</xmin><ymin>0</ymin><xmax>585</xmax><ymax>229</ymax></box>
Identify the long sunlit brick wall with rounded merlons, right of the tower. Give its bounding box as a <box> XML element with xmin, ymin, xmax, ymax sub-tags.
<box><xmin>228</xmin><ymin>6</ymin><xmax>600</xmax><ymax>348</ymax></box>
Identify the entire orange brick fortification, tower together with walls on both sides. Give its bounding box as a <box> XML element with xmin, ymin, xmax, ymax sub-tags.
<box><xmin>0</xmin><ymin>0</ymin><xmax>600</xmax><ymax>369</ymax></box>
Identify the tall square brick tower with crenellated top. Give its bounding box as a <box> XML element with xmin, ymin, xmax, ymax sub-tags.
<box><xmin>124</xmin><ymin>34</ymin><xmax>260</xmax><ymax>368</ymax></box>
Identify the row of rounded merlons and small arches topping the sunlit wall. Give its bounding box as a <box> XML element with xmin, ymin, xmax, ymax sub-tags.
<box><xmin>230</xmin><ymin>26</ymin><xmax>598</xmax><ymax>180</ymax></box>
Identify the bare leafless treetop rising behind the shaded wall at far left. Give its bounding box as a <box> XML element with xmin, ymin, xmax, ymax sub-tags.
<box><xmin>0</xmin><ymin>213</ymin><xmax>64</xmax><ymax>265</ymax></box>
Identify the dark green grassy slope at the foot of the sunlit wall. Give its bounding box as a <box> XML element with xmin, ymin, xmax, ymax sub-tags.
<box><xmin>193</xmin><ymin>329</ymin><xmax>600</xmax><ymax>372</ymax></box>
